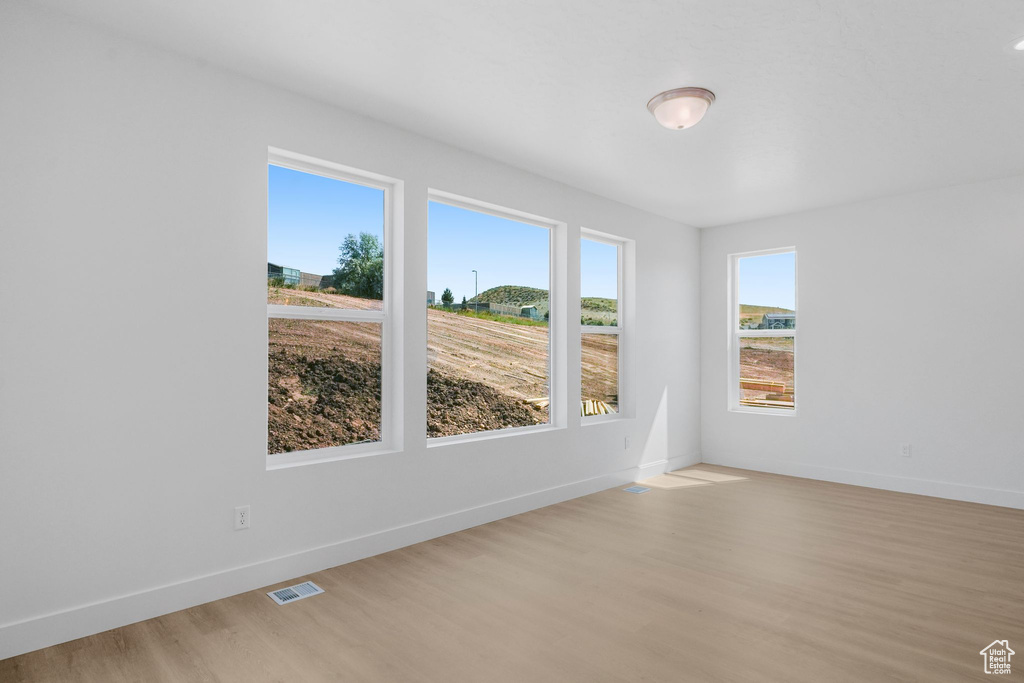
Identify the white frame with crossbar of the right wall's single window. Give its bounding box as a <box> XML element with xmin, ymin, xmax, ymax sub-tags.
<box><xmin>726</xmin><ymin>247</ymin><xmax>801</xmax><ymax>417</ymax></box>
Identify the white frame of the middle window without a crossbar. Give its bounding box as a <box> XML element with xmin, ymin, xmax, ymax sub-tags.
<box><xmin>423</xmin><ymin>187</ymin><xmax>568</xmax><ymax>449</ymax></box>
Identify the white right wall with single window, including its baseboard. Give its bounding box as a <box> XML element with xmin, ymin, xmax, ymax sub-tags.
<box><xmin>700</xmin><ymin>177</ymin><xmax>1024</xmax><ymax>508</ymax></box>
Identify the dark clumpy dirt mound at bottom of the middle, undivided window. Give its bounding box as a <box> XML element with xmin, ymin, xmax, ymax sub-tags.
<box><xmin>427</xmin><ymin>370</ymin><xmax>548</xmax><ymax>436</ymax></box>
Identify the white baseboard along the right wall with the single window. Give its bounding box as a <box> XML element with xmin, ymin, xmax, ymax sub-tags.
<box><xmin>705</xmin><ymin>456</ymin><xmax>1024</xmax><ymax>510</ymax></box>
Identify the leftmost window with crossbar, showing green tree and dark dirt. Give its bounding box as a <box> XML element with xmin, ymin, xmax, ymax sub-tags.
<box><xmin>266</xmin><ymin>152</ymin><xmax>392</xmax><ymax>464</ymax></box>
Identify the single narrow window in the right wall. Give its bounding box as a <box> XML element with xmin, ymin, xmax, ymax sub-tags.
<box><xmin>729</xmin><ymin>249</ymin><xmax>797</xmax><ymax>413</ymax></box>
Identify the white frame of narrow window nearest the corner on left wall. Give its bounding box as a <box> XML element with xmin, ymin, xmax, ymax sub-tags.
<box><xmin>577</xmin><ymin>227</ymin><xmax>633</xmax><ymax>425</ymax></box>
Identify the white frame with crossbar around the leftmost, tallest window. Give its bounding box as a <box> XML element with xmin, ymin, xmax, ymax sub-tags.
<box><xmin>265</xmin><ymin>147</ymin><xmax>403</xmax><ymax>470</ymax></box>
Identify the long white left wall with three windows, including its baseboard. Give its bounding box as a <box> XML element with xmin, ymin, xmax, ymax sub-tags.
<box><xmin>0</xmin><ymin>2</ymin><xmax>699</xmax><ymax>657</ymax></box>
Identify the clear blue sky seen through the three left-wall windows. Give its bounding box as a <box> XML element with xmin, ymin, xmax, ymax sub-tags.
<box><xmin>267</xmin><ymin>165</ymin><xmax>617</xmax><ymax>301</ymax></box>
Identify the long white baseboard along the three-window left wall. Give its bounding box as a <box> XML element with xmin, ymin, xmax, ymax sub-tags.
<box><xmin>0</xmin><ymin>460</ymin><xmax>670</xmax><ymax>659</ymax></box>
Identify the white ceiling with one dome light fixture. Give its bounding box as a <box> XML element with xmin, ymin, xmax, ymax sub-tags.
<box><xmin>32</xmin><ymin>0</ymin><xmax>1024</xmax><ymax>226</ymax></box>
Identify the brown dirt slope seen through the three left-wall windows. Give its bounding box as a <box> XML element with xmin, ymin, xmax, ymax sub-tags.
<box><xmin>267</xmin><ymin>288</ymin><xmax>617</xmax><ymax>453</ymax></box>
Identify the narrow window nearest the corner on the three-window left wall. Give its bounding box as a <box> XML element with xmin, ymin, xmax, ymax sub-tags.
<box><xmin>580</xmin><ymin>230</ymin><xmax>624</xmax><ymax>419</ymax></box>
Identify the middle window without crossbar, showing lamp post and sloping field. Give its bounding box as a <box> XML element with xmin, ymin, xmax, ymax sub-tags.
<box><xmin>427</xmin><ymin>195</ymin><xmax>552</xmax><ymax>437</ymax></box>
